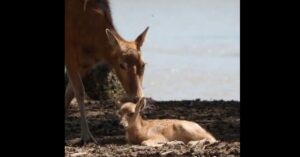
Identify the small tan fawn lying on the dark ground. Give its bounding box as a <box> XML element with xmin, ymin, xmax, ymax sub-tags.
<box><xmin>119</xmin><ymin>98</ymin><xmax>216</xmax><ymax>146</ymax></box>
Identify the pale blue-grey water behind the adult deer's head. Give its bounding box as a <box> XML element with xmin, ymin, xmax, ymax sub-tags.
<box><xmin>110</xmin><ymin>0</ymin><xmax>240</xmax><ymax>101</ymax></box>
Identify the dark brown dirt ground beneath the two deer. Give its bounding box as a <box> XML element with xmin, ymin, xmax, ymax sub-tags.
<box><xmin>65</xmin><ymin>99</ymin><xmax>240</xmax><ymax>157</ymax></box>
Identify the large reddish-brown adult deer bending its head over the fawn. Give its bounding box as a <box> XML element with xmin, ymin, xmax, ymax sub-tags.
<box><xmin>65</xmin><ymin>0</ymin><xmax>148</xmax><ymax>144</ymax></box>
